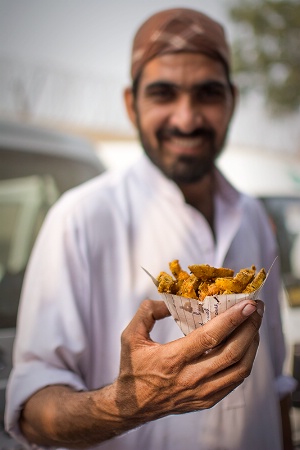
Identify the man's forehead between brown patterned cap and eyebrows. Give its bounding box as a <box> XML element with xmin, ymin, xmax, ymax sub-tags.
<box><xmin>140</xmin><ymin>53</ymin><xmax>227</xmax><ymax>87</ymax></box>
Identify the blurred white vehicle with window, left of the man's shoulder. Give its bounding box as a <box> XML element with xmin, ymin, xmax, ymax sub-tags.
<box><xmin>0</xmin><ymin>121</ymin><xmax>104</xmax><ymax>450</ymax></box>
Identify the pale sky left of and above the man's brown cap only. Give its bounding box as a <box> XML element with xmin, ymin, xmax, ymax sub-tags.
<box><xmin>0</xmin><ymin>0</ymin><xmax>227</xmax><ymax>77</ymax></box>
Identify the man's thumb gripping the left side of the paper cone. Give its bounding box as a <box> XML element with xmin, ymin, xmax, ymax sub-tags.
<box><xmin>123</xmin><ymin>300</ymin><xmax>170</xmax><ymax>339</ymax></box>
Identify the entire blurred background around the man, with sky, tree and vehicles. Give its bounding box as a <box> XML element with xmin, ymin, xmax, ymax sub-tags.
<box><xmin>0</xmin><ymin>0</ymin><xmax>300</xmax><ymax>449</ymax></box>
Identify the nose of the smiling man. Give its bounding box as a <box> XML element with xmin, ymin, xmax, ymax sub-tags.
<box><xmin>170</xmin><ymin>94</ymin><xmax>204</xmax><ymax>133</ymax></box>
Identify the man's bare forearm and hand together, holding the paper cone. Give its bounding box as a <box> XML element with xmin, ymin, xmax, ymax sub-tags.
<box><xmin>20</xmin><ymin>300</ymin><xmax>263</xmax><ymax>448</ymax></box>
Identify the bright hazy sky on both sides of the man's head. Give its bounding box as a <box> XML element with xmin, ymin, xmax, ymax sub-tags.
<box><xmin>0</xmin><ymin>0</ymin><xmax>300</xmax><ymax>151</ymax></box>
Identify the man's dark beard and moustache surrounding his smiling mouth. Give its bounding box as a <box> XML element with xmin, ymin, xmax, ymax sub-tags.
<box><xmin>138</xmin><ymin>120</ymin><xmax>225</xmax><ymax>184</ymax></box>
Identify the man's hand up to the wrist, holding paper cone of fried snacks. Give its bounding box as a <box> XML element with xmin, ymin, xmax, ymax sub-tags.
<box><xmin>116</xmin><ymin>300</ymin><xmax>263</xmax><ymax>423</ymax></box>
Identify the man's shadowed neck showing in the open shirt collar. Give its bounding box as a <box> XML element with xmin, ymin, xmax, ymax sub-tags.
<box><xmin>178</xmin><ymin>173</ymin><xmax>214</xmax><ymax>232</ymax></box>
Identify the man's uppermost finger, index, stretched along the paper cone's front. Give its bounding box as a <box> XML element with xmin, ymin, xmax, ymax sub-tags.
<box><xmin>180</xmin><ymin>300</ymin><xmax>263</xmax><ymax>360</ymax></box>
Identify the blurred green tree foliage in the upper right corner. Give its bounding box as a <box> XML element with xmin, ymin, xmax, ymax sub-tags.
<box><xmin>229</xmin><ymin>0</ymin><xmax>300</xmax><ymax>115</ymax></box>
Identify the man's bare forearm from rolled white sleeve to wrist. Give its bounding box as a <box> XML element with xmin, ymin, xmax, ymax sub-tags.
<box><xmin>20</xmin><ymin>384</ymin><xmax>149</xmax><ymax>448</ymax></box>
